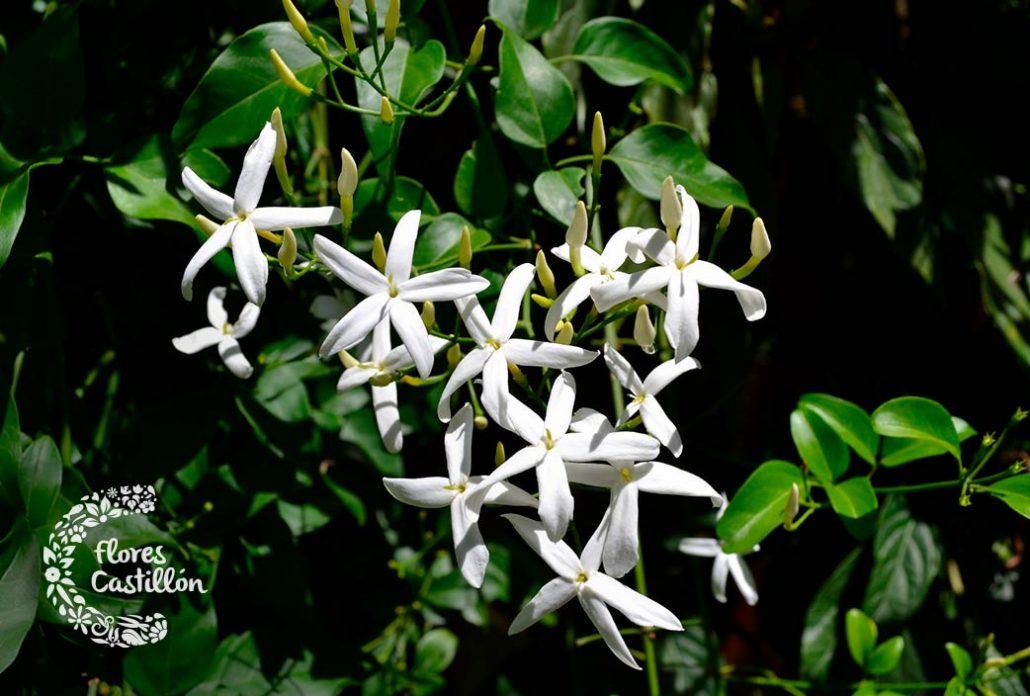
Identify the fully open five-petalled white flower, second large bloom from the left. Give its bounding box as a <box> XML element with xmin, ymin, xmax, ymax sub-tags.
<box><xmin>314</xmin><ymin>210</ymin><xmax>490</xmax><ymax>377</ymax></box>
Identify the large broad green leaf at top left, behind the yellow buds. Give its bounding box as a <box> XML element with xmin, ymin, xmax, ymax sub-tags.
<box><xmin>172</xmin><ymin>22</ymin><xmax>342</xmax><ymax>150</ymax></box>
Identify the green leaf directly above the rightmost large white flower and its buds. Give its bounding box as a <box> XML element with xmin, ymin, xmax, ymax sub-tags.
<box><xmin>607</xmin><ymin>124</ymin><xmax>751</xmax><ymax>210</ymax></box>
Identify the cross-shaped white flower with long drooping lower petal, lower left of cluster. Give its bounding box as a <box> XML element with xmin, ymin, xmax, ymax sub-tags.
<box><xmin>383</xmin><ymin>404</ymin><xmax>537</xmax><ymax>587</ymax></box>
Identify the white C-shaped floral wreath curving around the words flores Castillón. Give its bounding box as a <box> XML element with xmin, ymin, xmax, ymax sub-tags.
<box><xmin>43</xmin><ymin>485</ymin><xmax>168</xmax><ymax>648</ymax></box>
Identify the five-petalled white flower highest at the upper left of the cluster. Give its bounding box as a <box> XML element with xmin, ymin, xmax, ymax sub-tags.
<box><xmin>182</xmin><ymin>123</ymin><xmax>343</xmax><ymax>305</ymax></box>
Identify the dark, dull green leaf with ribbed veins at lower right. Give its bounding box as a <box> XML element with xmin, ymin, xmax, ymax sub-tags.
<box><xmin>862</xmin><ymin>496</ymin><xmax>940</xmax><ymax>623</ymax></box>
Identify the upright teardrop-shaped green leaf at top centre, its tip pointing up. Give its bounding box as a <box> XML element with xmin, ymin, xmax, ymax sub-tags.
<box><xmin>495</xmin><ymin>25</ymin><xmax>576</xmax><ymax>148</ymax></box>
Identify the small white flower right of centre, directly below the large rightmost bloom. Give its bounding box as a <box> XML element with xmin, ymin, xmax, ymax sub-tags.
<box><xmin>605</xmin><ymin>343</ymin><xmax>701</xmax><ymax>457</ymax></box>
